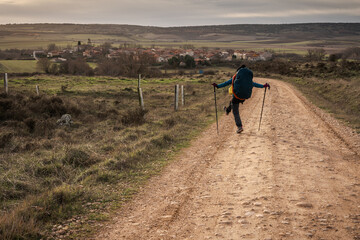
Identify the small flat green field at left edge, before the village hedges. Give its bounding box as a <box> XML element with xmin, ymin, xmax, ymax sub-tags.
<box><xmin>0</xmin><ymin>60</ymin><xmax>37</xmax><ymax>73</ymax></box>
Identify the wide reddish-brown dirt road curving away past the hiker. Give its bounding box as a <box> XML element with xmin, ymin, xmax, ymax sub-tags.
<box><xmin>98</xmin><ymin>79</ymin><xmax>360</xmax><ymax>240</ymax></box>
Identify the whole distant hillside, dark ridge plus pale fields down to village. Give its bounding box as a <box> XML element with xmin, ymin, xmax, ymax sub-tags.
<box><xmin>0</xmin><ymin>23</ymin><xmax>360</xmax><ymax>52</ymax></box>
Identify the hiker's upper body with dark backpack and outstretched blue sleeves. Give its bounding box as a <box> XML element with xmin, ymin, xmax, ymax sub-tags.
<box><xmin>218</xmin><ymin>68</ymin><xmax>264</xmax><ymax>99</ymax></box>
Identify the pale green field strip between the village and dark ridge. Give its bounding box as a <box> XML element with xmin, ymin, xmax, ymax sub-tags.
<box><xmin>0</xmin><ymin>34</ymin><xmax>317</xmax><ymax>54</ymax></box>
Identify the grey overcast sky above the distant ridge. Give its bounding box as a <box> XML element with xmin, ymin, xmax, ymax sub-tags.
<box><xmin>0</xmin><ymin>0</ymin><xmax>360</xmax><ymax>27</ymax></box>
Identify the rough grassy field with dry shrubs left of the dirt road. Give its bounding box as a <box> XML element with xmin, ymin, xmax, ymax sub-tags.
<box><xmin>0</xmin><ymin>75</ymin><xmax>228</xmax><ymax>239</ymax></box>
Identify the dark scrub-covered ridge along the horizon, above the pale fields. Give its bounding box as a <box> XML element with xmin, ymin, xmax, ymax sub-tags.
<box><xmin>0</xmin><ymin>23</ymin><xmax>360</xmax><ymax>40</ymax></box>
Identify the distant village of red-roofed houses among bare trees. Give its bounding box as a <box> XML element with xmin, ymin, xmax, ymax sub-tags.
<box><xmin>33</xmin><ymin>39</ymin><xmax>273</xmax><ymax>66</ymax></box>
